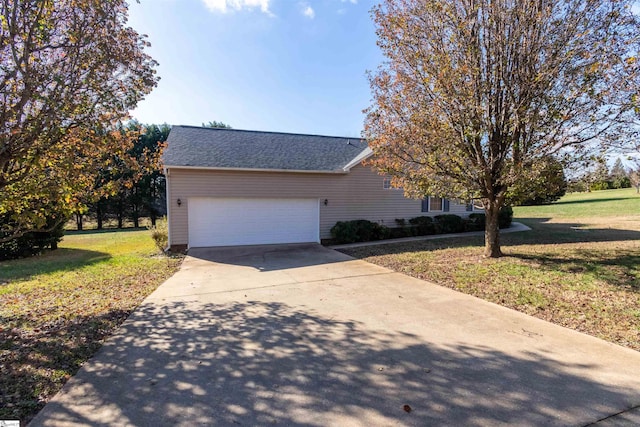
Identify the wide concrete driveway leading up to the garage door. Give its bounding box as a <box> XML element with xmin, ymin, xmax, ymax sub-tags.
<box><xmin>31</xmin><ymin>245</ymin><xmax>640</xmax><ymax>426</ymax></box>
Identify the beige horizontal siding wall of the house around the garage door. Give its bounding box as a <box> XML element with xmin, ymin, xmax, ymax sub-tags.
<box><xmin>167</xmin><ymin>165</ymin><xmax>466</xmax><ymax>246</ymax></box>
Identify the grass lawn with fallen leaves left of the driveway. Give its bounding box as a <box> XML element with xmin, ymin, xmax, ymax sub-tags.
<box><xmin>0</xmin><ymin>230</ymin><xmax>180</xmax><ymax>421</ymax></box>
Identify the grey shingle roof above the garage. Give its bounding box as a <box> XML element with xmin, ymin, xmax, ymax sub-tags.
<box><xmin>163</xmin><ymin>126</ymin><xmax>367</xmax><ymax>172</ymax></box>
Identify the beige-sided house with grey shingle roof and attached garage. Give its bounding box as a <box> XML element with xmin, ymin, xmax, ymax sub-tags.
<box><xmin>163</xmin><ymin>126</ymin><xmax>467</xmax><ymax>249</ymax></box>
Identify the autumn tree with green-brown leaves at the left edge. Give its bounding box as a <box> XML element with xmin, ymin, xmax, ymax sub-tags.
<box><xmin>0</xmin><ymin>0</ymin><xmax>157</xmax><ymax>241</ymax></box>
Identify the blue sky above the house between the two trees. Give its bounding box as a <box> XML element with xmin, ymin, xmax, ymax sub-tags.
<box><xmin>129</xmin><ymin>0</ymin><xmax>383</xmax><ymax>136</ymax></box>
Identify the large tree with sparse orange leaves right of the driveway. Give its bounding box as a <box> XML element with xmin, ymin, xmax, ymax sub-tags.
<box><xmin>365</xmin><ymin>0</ymin><xmax>640</xmax><ymax>257</ymax></box>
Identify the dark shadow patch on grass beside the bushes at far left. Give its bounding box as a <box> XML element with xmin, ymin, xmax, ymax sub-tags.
<box><xmin>0</xmin><ymin>248</ymin><xmax>111</xmax><ymax>286</ymax></box>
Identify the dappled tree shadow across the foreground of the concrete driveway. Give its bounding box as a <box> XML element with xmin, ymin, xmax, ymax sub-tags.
<box><xmin>31</xmin><ymin>301</ymin><xmax>639</xmax><ymax>427</ymax></box>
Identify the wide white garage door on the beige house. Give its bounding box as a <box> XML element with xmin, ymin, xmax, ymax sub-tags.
<box><xmin>188</xmin><ymin>198</ymin><xmax>320</xmax><ymax>248</ymax></box>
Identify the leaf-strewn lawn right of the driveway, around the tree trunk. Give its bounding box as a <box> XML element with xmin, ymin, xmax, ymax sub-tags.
<box><xmin>342</xmin><ymin>189</ymin><xmax>640</xmax><ymax>350</ymax></box>
